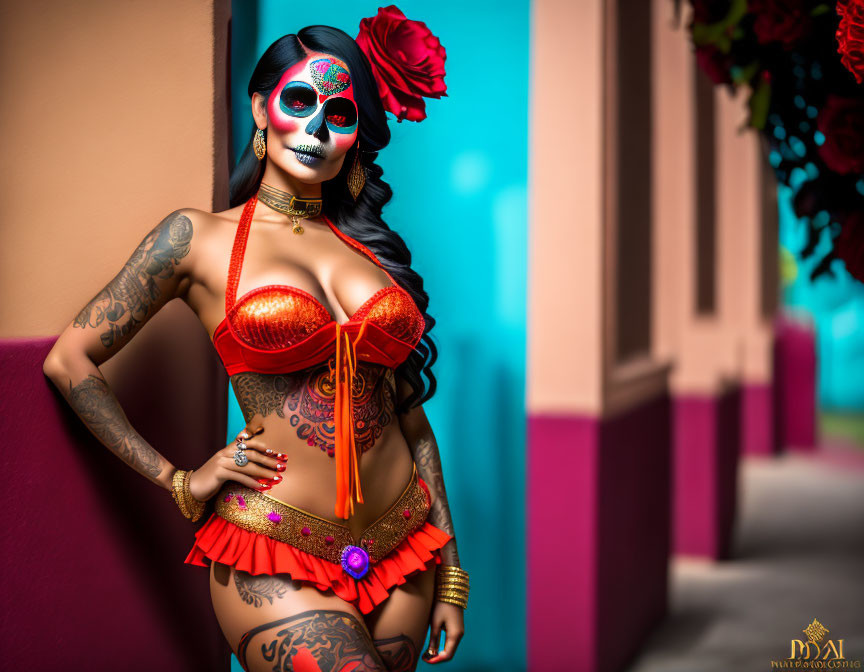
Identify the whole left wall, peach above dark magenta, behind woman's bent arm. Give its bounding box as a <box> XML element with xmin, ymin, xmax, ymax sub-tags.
<box><xmin>0</xmin><ymin>0</ymin><xmax>230</xmax><ymax>671</ymax></box>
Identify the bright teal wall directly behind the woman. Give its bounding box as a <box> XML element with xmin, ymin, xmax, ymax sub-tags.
<box><xmin>228</xmin><ymin>0</ymin><xmax>529</xmax><ymax>672</ymax></box>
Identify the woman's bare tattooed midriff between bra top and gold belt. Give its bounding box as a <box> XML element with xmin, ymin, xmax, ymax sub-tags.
<box><xmin>231</xmin><ymin>362</ymin><xmax>413</xmax><ymax>538</ymax></box>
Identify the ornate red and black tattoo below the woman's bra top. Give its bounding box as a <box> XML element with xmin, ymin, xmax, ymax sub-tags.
<box><xmin>231</xmin><ymin>362</ymin><xmax>396</xmax><ymax>457</ymax></box>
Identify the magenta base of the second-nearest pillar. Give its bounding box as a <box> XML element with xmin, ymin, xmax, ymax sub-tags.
<box><xmin>672</xmin><ymin>387</ymin><xmax>741</xmax><ymax>560</ymax></box>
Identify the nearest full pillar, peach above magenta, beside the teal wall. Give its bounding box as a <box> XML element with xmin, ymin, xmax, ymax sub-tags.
<box><xmin>527</xmin><ymin>0</ymin><xmax>669</xmax><ymax>672</ymax></box>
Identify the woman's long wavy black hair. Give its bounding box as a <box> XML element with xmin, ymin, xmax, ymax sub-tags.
<box><xmin>230</xmin><ymin>26</ymin><xmax>438</xmax><ymax>413</ymax></box>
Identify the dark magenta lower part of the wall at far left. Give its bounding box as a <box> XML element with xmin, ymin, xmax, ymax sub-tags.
<box><xmin>0</xmin><ymin>338</ymin><xmax>230</xmax><ymax>672</ymax></box>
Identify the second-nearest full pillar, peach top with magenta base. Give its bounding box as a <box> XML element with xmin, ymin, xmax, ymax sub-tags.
<box><xmin>653</xmin><ymin>3</ymin><xmax>740</xmax><ymax>558</ymax></box>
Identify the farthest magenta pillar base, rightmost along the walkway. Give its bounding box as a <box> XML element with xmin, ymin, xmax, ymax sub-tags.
<box><xmin>774</xmin><ymin>317</ymin><xmax>818</xmax><ymax>451</ymax></box>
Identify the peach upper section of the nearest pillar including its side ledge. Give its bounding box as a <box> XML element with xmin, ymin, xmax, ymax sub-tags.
<box><xmin>527</xmin><ymin>0</ymin><xmax>668</xmax><ymax>416</ymax></box>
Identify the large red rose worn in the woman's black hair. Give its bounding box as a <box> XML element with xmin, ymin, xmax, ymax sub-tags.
<box><xmin>355</xmin><ymin>5</ymin><xmax>447</xmax><ymax>122</ymax></box>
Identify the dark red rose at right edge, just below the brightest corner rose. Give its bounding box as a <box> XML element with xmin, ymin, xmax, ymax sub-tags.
<box><xmin>816</xmin><ymin>95</ymin><xmax>864</xmax><ymax>175</ymax></box>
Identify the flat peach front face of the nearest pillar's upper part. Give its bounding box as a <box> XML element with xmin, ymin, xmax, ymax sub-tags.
<box><xmin>527</xmin><ymin>0</ymin><xmax>605</xmax><ymax>413</ymax></box>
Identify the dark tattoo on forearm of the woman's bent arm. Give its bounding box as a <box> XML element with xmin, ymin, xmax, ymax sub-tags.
<box><xmin>66</xmin><ymin>373</ymin><xmax>162</xmax><ymax>478</ymax></box>
